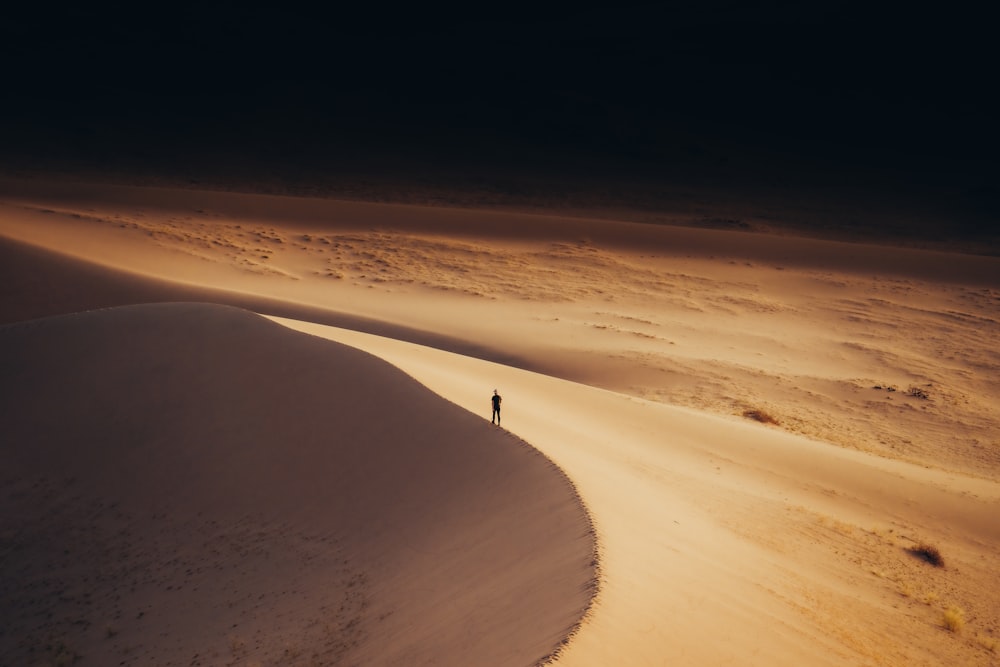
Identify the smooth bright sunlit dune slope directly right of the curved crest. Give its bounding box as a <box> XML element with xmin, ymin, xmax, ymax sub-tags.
<box><xmin>273</xmin><ymin>318</ymin><xmax>1000</xmax><ymax>667</ymax></box>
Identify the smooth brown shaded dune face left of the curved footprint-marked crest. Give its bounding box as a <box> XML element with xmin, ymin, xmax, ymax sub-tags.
<box><xmin>0</xmin><ymin>304</ymin><xmax>595</xmax><ymax>665</ymax></box>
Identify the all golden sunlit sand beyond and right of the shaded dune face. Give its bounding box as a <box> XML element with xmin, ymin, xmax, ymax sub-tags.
<box><xmin>0</xmin><ymin>183</ymin><xmax>1000</xmax><ymax>665</ymax></box>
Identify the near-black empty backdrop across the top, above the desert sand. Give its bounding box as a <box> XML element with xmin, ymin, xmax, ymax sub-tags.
<box><xmin>0</xmin><ymin>0</ymin><xmax>1000</xmax><ymax>201</ymax></box>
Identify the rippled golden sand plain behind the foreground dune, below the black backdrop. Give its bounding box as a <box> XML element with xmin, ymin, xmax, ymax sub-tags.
<box><xmin>0</xmin><ymin>182</ymin><xmax>1000</xmax><ymax>476</ymax></box>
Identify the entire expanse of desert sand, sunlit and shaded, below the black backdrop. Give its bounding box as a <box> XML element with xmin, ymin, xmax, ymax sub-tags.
<box><xmin>0</xmin><ymin>181</ymin><xmax>1000</xmax><ymax>666</ymax></box>
